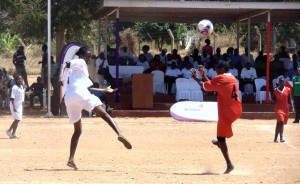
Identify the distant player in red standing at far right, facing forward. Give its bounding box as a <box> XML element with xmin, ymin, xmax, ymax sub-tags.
<box><xmin>273</xmin><ymin>77</ymin><xmax>291</xmax><ymax>142</ymax></box>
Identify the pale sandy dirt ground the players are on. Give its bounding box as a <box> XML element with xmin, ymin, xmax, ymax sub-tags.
<box><xmin>0</xmin><ymin>114</ymin><xmax>300</xmax><ymax>184</ymax></box>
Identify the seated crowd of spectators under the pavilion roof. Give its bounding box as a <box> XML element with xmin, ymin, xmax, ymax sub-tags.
<box><xmin>98</xmin><ymin>39</ymin><xmax>300</xmax><ymax>98</ymax></box>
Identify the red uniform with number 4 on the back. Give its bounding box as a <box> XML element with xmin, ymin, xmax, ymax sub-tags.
<box><xmin>203</xmin><ymin>73</ymin><xmax>242</xmax><ymax>138</ymax></box>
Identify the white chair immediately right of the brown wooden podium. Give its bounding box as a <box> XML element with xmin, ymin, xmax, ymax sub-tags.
<box><xmin>151</xmin><ymin>70</ymin><xmax>166</xmax><ymax>94</ymax></box>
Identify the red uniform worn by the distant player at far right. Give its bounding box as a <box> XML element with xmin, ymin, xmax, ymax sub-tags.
<box><xmin>274</xmin><ymin>87</ymin><xmax>291</xmax><ymax>124</ymax></box>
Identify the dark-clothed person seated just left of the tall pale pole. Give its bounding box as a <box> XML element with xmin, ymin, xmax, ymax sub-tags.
<box><xmin>29</xmin><ymin>77</ymin><xmax>44</xmax><ymax>109</ymax></box>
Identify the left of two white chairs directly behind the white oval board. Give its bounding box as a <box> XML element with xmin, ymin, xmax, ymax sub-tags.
<box><xmin>176</xmin><ymin>78</ymin><xmax>191</xmax><ymax>101</ymax></box>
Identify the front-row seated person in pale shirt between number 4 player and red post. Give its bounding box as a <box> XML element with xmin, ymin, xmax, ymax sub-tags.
<box><xmin>240</xmin><ymin>62</ymin><xmax>257</xmax><ymax>91</ymax></box>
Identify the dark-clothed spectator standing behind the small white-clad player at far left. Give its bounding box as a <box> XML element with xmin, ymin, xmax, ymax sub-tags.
<box><xmin>13</xmin><ymin>46</ymin><xmax>29</xmax><ymax>88</ymax></box>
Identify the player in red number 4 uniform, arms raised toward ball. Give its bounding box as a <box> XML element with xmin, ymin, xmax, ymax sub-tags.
<box><xmin>191</xmin><ymin>61</ymin><xmax>242</xmax><ymax>174</ymax></box>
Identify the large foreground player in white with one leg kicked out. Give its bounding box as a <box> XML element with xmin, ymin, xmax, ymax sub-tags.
<box><xmin>63</xmin><ymin>47</ymin><xmax>132</xmax><ymax>169</ymax></box>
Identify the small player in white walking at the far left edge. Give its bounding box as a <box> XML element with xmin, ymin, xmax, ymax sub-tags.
<box><xmin>6</xmin><ymin>74</ymin><xmax>25</xmax><ymax>139</ymax></box>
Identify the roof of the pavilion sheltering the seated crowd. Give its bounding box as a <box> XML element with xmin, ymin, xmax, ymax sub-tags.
<box><xmin>92</xmin><ymin>0</ymin><xmax>300</xmax><ymax>23</ymax></box>
